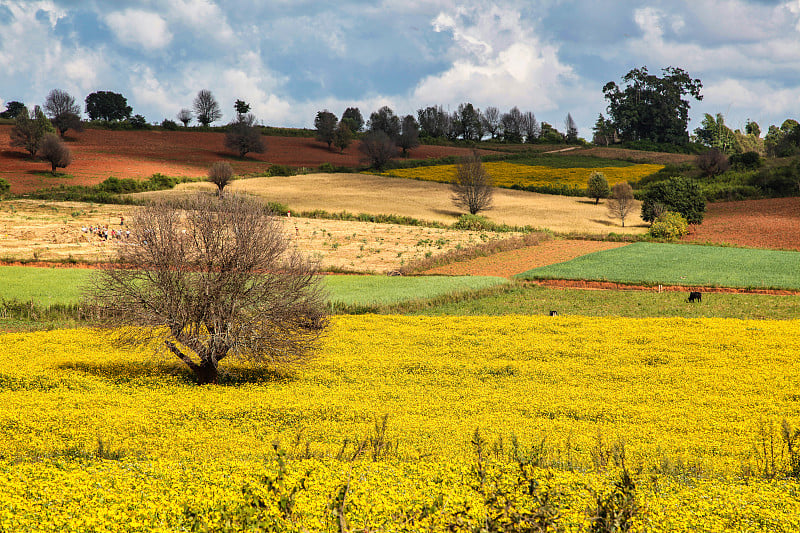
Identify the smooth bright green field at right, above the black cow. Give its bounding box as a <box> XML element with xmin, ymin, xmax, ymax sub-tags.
<box><xmin>517</xmin><ymin>242</ymin><xmax>800</xmax><ymax>290</ymax></box>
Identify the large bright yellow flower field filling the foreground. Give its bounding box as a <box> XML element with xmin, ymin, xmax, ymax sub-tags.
<box><xmin>0</xmin><ymin>316</ymin><xmax>800</xmax><ymax>532</ymax></box>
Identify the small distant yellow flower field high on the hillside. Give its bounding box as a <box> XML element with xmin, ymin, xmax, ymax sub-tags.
<box><xmin>384</xmin><ymin>161</ymin><xmax>664</xmax><ymax>189</ymax></box>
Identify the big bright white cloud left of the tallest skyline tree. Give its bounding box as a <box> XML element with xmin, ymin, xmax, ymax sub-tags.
<box><xmin>413</xmin><ymin>2</ymin><xmax>576</xmax><ymax>112</ymax></box>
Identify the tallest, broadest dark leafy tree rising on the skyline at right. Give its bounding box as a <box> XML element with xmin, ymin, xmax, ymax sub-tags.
<box><xmin>603</xmin><ymin>67</ymin><xmax>703</xmax><ymax>144</ymax></box>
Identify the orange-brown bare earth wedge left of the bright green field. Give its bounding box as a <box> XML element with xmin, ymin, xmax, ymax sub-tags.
<box><xmin>424</xmin><ymin>240</ymin><xmax>627</xmax><ymax>278</ymax></box>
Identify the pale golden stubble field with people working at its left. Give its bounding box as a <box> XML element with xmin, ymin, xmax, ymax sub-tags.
<box><xmin>0</xmin><ymin>200</ymin><xmax>516</xmax><ymax>272</ymax></box>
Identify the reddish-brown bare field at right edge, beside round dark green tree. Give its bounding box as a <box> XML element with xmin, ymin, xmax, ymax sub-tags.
<box><xmin>683</xmin><ymin>197</ymin><xmax>800</xmax><ymax>251</ymax></box>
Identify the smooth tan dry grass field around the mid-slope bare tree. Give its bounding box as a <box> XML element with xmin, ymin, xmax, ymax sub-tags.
<box><xmin>148</xmin><ymin>174</ymin><xmax>647</xmax><ymax>234</ymax></box>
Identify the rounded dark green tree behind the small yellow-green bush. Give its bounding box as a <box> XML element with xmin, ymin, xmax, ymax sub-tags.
<box><xmin>642</xmin><ymin>176</ymin><xmax>706</xmax><ymax>224</ymax></box>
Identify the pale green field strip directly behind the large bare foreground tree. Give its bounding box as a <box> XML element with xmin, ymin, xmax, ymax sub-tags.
<box><xmin>0</xmin><ymin>266</ymin><xmax>508</xmax><ymax>308</ymax></box>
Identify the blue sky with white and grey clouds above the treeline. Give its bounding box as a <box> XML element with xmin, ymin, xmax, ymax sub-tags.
<box><xmin>0</xmin><ymin>0</ymin><xmax>800</xmax><ymax>138</ymax></box>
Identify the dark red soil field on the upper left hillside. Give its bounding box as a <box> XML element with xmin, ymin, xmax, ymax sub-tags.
<box><xmin>0</xmin><ymin>125</ymin><xmax>491</xmax><ymax>194</ymax></box>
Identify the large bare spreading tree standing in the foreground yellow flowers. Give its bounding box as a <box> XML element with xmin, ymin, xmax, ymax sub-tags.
<box><xmin>86</xmin><ymin>195</ymin><xmax>327</xmax><ymax>384</ymax></box>
